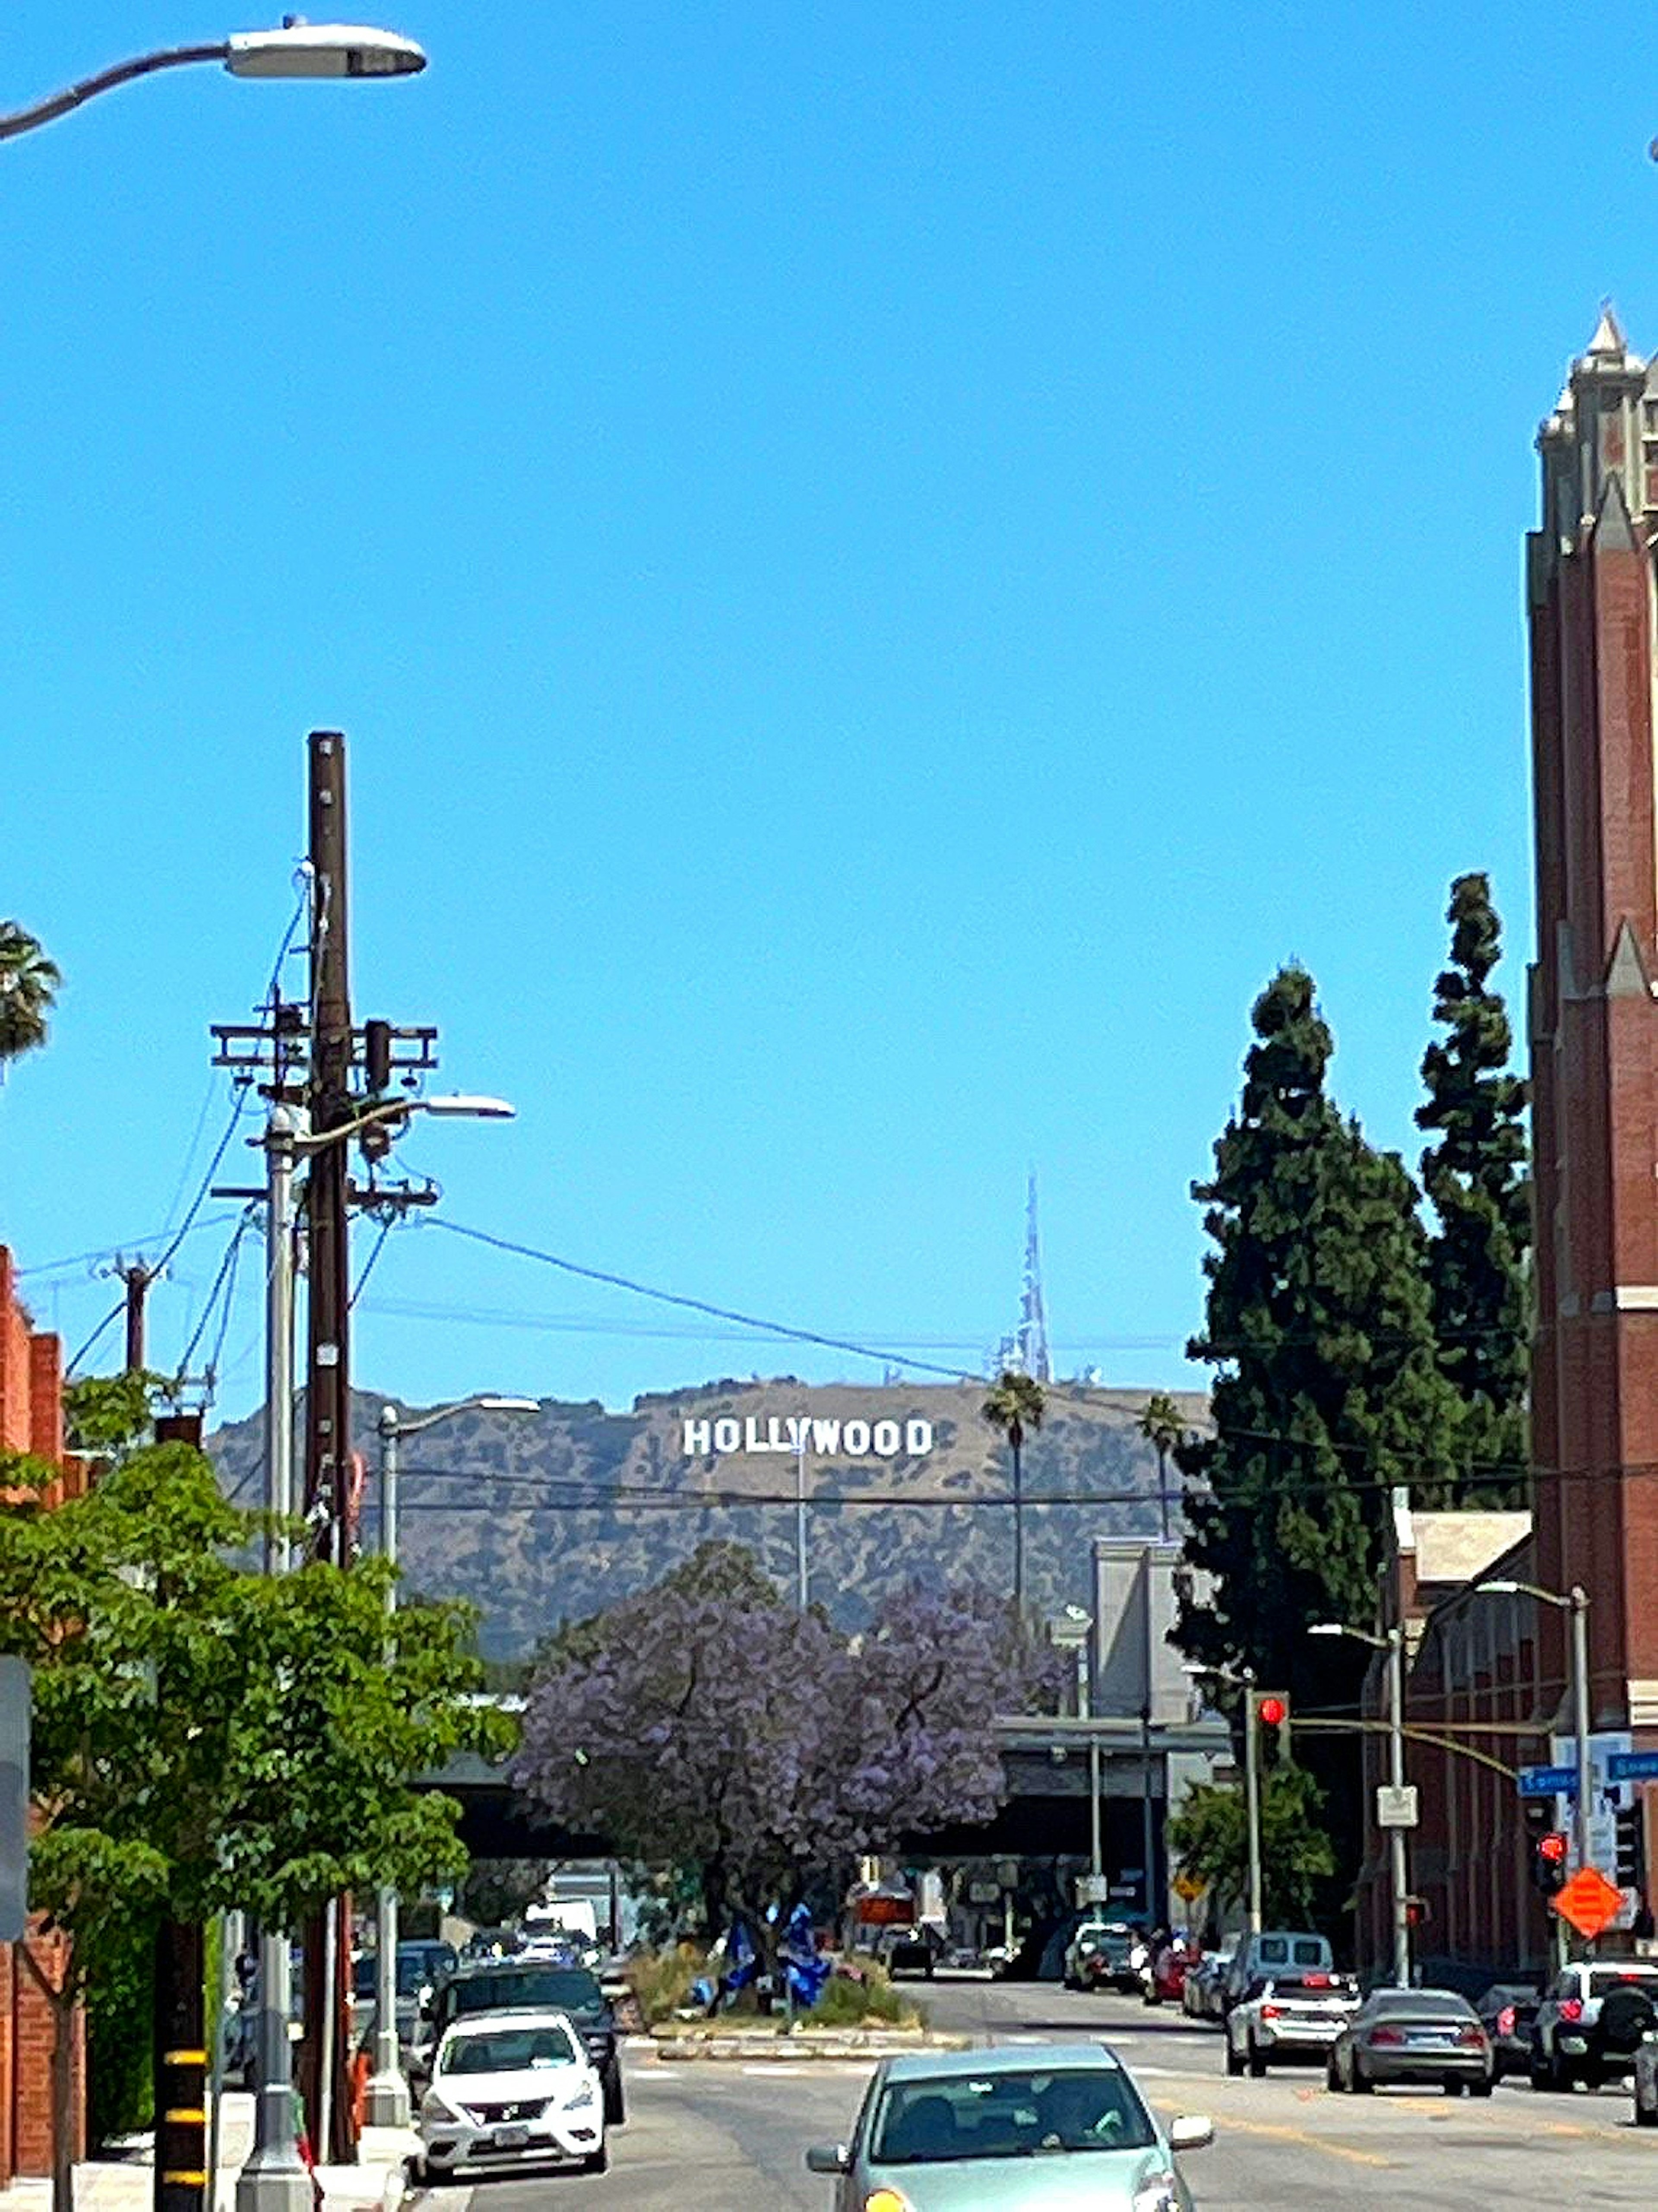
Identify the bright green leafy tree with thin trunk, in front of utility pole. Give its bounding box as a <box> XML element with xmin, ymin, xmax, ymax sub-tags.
<box><xmin>0</xmin><ymin>1445</ymin><xmax>497</xmax><ymax>2212</ymax></box>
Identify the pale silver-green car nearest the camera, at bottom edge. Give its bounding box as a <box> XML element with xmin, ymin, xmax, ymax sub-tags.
<box><xmin>807</xmin><ymin>2044</ymin><xmax>1214</xmax><ymax>2212</ymax></box>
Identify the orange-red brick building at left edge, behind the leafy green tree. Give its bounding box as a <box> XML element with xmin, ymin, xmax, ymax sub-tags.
<box><xmin>0</xmin><ymin>1245</ymin><xmax>86</xmax><ymax>2188</ymax></box>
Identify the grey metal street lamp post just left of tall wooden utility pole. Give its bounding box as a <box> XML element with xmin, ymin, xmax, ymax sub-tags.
<box><xmin>237</xmin><ymin>1097</ymin><xmax>513</xmax><ymax>2212</ymax></box>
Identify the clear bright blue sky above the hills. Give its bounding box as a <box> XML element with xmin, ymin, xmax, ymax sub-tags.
<box><xmin>0</xmin><ymin>0</ymin><xmax>1658</xmax><ymax>1411</ymax></box>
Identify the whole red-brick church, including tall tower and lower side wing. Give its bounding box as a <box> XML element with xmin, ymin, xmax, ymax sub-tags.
<box><xmin>1360</xmin><ymin>310</ymin><xmax>1658</xmax><ymax>1966</ymax></box>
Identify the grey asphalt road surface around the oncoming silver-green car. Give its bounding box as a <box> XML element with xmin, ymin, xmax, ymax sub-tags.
<box><xmin>409</xmin><ymin>1980</ymin><xmax>1658</xmax><ymax>2212</ymax></box>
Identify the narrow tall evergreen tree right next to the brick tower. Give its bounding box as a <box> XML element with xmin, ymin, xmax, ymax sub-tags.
<box><xmin>1417</xmin><ymin>876</ymin><xmax>1532</xmax><ymax>1495</ymax></box>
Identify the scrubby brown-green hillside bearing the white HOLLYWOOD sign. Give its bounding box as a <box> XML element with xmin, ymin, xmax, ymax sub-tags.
<box><xmin>208</xmin><ymin>1378</ymin><xmax>1202</xmax><ymax>1659</ymax></box>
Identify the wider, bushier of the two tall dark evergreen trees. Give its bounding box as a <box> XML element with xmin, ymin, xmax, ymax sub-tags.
<box><xmin>1176</xmin><ymin>967</ymin><xmax>1457</xmax><ymax>1701</ymax></box>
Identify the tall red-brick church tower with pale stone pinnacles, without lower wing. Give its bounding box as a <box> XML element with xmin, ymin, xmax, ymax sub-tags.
<box><xmin>1528</xmin><ymin>307</ymin><xmax>1658</xmax><ymax>1727</ymax></box>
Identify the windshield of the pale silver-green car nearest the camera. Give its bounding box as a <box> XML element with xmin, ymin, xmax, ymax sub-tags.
<box><xmin>871</xmin><ymin>2066</ymin><xmax>1156</xmax><ymax>2165</ymax></box>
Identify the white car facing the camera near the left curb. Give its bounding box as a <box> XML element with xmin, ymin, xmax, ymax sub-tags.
<box><xmin>418</xmin><ymin>2013</ymin><xmax>610</xmax><ymax>2181</ymax></box>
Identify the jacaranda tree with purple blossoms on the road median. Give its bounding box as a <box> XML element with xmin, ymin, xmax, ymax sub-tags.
<box><xmin>513</xmin><ymin>1544</ymin><xmax>1052</xmax><ymax>1931</ymax></box>
